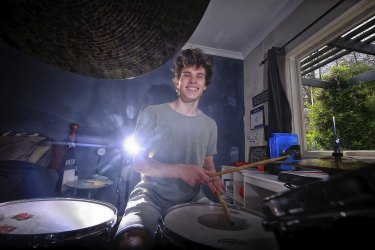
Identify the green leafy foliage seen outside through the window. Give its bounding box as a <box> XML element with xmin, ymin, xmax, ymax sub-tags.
<box><xmin>305</xmin><ymin>61</ymin><xmax>375</xmax><ymax>150</ymax></box>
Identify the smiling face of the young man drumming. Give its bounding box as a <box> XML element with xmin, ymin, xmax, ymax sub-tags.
<box><xmin>175</xmin><ymin>67</ymin><xmax>206</xmax><ymax>103</ymax></box>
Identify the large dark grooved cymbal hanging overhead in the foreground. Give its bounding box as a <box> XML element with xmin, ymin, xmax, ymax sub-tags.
<box><xmin>0</xmin><ymin>0</ymin><xmax>209</xmax><ymax>79</ymax></box>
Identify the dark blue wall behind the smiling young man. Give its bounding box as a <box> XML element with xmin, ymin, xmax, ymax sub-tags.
<box><xmin>0</xmin><ymin>40</ymin><xmax>244</xmax><ymax>207</ymax></box>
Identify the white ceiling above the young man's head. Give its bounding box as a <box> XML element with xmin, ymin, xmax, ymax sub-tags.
<box><xmin>185</xmin><ymin>0</ymin><xmax>303</xmax><ymax>59</ymax></box>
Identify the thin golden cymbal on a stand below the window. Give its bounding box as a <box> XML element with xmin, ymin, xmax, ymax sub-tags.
<box><xmin>277</xmin><ymin>156</ymin><xmax>369</xmax><ymax>170</ymax></box>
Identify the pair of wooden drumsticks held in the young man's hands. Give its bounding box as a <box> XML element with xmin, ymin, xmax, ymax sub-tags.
<box><xmin>210</xmin><ymin>155</ymin><xmax>289</xmax><ymax>224</ymax></box>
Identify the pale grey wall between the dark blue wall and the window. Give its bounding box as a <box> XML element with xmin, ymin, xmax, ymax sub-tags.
<box><xmin>244</xmin><ymin>0</ymin><xmax>359</xmax><ymax>160</ymax></box>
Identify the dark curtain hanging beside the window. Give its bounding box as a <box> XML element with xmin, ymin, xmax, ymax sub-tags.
<box><xmin>267</xmin><ymin>47</ymin><xmax>292</xmax><ymax>136</ymax></box>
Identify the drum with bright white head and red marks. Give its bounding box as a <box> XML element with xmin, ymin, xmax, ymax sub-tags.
<box><xmin>0</xmin><ymin>198</ymin><xmax>117</xmax><ymax>249</ymax></box>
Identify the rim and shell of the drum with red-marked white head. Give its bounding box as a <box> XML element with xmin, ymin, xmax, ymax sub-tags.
<box><xmin>0</xmin><ymin>197</ymin><xmax>117</xmax><ymax>247</ymax></box>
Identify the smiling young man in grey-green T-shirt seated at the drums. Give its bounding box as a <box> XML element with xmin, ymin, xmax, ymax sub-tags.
<box><xmin>114</xmin><ymin>49</ymin><xmax>223</xmax><ymax>249</ymax></box>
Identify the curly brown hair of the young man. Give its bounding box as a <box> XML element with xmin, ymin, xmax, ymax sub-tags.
<box><xmin>172</xmin><ymin>48</ymin><xmax>214</xmax><ymax>86</ymax></box>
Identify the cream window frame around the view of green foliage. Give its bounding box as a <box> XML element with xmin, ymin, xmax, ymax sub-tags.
<box><xmin>285</xmin><ymin>1</ymin><xmax>375</xmax><ymax>159</ymax></box>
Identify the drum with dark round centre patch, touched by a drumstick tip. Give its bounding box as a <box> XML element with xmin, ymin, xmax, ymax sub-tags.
<box><xmin>156</xmin><ymin>203</ymin><xmax>278</xmax><ymax>250</ymax></box>
